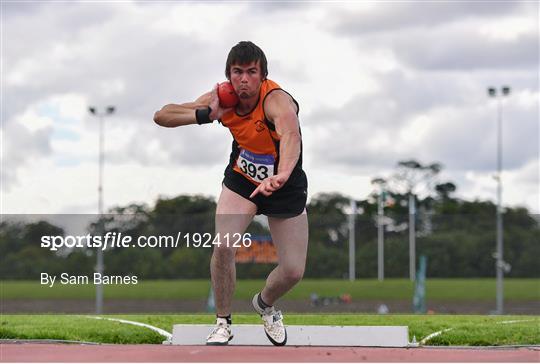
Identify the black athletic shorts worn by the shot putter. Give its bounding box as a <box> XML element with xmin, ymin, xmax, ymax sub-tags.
<box><xmin>223</xmin><ymin>166</ymin><xmax>307</xmax><ymax>218</ymax></box>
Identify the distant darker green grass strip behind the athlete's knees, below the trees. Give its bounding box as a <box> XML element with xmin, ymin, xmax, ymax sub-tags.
<box><xmin>0</xmin><ymin>278</ymin><xmax>540</xmax><ymax>301</ymax></box>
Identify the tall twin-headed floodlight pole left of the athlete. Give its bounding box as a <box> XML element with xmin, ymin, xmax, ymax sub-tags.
<box><xmin>88</xmin><ymin>106</ymin><xmax>115</xmax><ymax>314</ymax></box>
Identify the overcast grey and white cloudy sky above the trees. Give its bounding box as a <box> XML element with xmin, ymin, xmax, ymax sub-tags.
<box><xmin>1</xmin><ymin>1</ymin><xmax>540</xmax><ymax>214</ymax></box>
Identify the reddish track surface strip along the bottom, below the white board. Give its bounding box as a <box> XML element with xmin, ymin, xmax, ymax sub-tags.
<box><xmin>0</xmin><ymin>343</ymin><xmax>540</xmax><ymax>363</ymax></box>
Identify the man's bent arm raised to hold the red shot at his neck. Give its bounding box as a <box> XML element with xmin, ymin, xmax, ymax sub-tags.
<box><xmin>154</xmin><ymin>85</ymin><xmax>228</xmax><ymax>128</ymax></box>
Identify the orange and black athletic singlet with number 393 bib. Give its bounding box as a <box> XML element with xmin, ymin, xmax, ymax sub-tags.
<box><xmin>220</xmin><ymin>80</ymin><xmax>302</xmax><ymax>186</ymax></box>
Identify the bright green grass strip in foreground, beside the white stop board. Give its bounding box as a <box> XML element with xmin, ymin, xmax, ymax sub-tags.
<box><xmin>0</xmin><ymin>314</ymin><xmax>540</xmax><ymax>346</ymax></box>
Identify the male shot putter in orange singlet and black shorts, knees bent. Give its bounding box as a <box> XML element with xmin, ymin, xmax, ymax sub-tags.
<box><xmin>154</xmin><ymin>41</ymin><xmax>308</xmax><ymax>346</ymax></box>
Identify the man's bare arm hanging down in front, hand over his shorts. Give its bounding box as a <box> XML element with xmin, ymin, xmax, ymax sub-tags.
<box><xmin>250</xmin><ymin>90</ymin><xmax>302</xmax><ymax>198</ymax></box>
